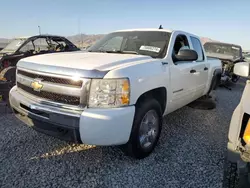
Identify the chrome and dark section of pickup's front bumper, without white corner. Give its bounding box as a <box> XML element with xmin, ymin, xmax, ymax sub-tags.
<box><xmin>9</xmin><ymin>86</ymin><xmax>81</xmax><ymax>143</ymax></box>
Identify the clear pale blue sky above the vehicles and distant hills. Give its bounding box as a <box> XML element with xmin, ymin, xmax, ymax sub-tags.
<box><xmin>0</xmin><ymin>0</ymin><xmax>250</xmax><ymax>50</ymax></box>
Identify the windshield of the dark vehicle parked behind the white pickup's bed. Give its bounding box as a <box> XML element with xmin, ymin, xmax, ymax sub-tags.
<box><xmin>204</xmin><ymin>43</ymin><xmax>241</xmax><ymax>59</ymax></box>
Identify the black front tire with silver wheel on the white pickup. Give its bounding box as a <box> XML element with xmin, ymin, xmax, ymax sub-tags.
<box><xmin>123</xmin><ymin>99</ymin><xmax>163</xmax><ymax>159</ymax></box>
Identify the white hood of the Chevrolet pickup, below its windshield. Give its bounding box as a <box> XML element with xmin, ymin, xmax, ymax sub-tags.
<box><xmin>17</xmin><ymin>52</ymin><xmax>154</xmax><ymax>77</ymax></box>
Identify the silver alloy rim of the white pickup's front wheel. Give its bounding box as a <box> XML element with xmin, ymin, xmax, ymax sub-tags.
<box><xmin>139</xmin><ymin>110</ymin><xmax>159</xmax><ymax>149</ymax></box>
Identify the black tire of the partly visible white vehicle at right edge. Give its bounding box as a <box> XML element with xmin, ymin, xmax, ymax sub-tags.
<box><xmin>223</xmin><ymin>159</ymin><xmax>250</xmax><ymax>188</ymax></box>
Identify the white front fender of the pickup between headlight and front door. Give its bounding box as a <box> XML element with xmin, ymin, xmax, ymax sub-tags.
<box><xmin>104</xmin><ymin>59</ymin><xmax>171</xmax><ymax>105</ymax></box>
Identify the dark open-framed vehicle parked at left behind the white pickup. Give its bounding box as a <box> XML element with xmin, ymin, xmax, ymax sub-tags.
<box><xmin>0</xmin><ymin>35</ymin><xmax>80</xmax><ymax>100</ymax></box>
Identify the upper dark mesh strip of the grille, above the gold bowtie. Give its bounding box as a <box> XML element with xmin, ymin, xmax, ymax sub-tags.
<box><xmin>17</xmin><ymin>70</ymin><xmax>82</xmax><ymax>87</ymax></box>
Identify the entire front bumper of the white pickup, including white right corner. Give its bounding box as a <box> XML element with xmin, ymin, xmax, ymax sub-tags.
<box><xmin>9</xmin><ymin>86</ymin><xmax>135</xmax><ymax>146</ymax></box>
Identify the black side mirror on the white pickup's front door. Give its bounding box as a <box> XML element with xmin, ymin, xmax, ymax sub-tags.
<box><xmin>174</xmin><ymin>49</ymin><xmax>198</xmax><ymax>62</ymax></box>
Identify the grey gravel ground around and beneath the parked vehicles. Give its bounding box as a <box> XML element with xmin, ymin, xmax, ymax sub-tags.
<box><xmin>0</xmin><ymin>83</ymin><xmax>244</xmax><ymax>188</ymax></box>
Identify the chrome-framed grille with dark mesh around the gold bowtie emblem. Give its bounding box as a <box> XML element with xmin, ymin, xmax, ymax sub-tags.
<box><xmin>16</xmin><ymin>68</ymin><xmax>90</xmax><ymax>108</ymax></box>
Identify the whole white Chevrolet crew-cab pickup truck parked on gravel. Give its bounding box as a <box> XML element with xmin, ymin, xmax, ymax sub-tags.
<box><xmin>9</xmin><ymin>29</ymin><xmax>221</xmax><ymax>159</ymax></box>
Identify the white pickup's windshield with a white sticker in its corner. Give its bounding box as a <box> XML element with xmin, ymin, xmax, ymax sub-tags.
<box><xmin>88</xmin><ymin>31</ymin><xmax>171</xmax><ymax>58</ymax></box>
